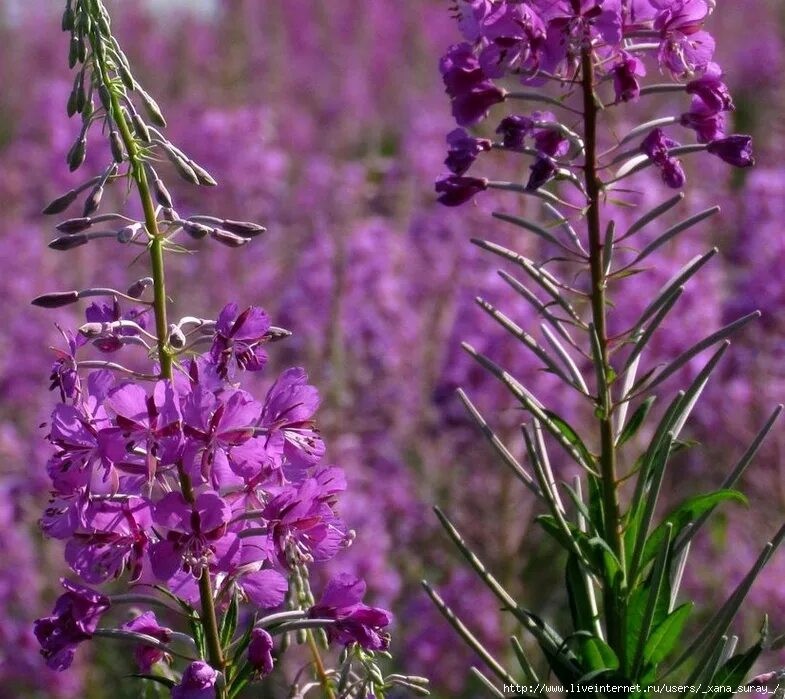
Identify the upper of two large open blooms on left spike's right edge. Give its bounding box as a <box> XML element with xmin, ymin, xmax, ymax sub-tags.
<box><xmin>259</xmin><ymin>367</ymin><xmax>324</xmax><ymax>468</ymax></box>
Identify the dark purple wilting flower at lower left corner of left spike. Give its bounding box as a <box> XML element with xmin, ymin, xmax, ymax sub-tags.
<box><xmin>33</xmin><ymin>579</ymin><xmax>110</xmax><ymax>670</ymax></box>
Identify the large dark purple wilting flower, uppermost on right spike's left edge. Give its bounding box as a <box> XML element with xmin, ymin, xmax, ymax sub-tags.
<box><xmin>439</xmin><ymin>43</ymin><xmax>505</xmax><ymax>126</ymax></box>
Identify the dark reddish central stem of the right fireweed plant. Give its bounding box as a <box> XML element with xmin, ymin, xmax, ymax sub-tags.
<box><xmin>581</xmin><ymin>46</ymin><xmax>624</xmax><ymax>649</ymax></box>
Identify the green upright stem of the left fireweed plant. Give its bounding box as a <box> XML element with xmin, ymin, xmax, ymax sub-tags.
<box><xmin>92</xmin><ymin>34</ymin><xmax>226</xmax><ymax>699</ymax></box>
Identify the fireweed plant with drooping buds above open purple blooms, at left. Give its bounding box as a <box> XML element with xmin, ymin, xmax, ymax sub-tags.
<box><xmin>33</xmin><ymin>0</ymin><xmax>428</xmax><ymax>699</ymax></box>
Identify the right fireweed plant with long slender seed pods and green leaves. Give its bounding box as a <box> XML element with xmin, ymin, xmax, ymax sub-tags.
<box><xmin>425</xmin><ymin>0</ymin><xmax>785</xmax><ymax>697</ymax></box>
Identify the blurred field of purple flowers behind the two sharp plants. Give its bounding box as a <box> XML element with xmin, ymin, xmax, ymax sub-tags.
<box><xmin>0</xmin><ymin>0</ymin><xmax>785</xmax><ymax>699</ymax></box>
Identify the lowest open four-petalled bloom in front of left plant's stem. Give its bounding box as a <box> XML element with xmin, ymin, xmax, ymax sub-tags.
<box><xmin>150</xmin><ymin>491</ymin><xmax>240</xmax><ymax>580</ymax></box>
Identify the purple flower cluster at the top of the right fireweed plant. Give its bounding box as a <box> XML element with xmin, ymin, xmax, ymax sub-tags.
<box><xmin>436</xmin><ymin>0</ymin><xmax>753</xmax><ymax>206</ymax></box>
